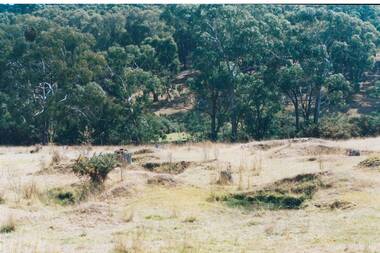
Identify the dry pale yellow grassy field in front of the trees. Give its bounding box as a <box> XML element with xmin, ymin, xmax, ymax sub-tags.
<box><xmin>0</xmin><ymin>137</ymin><xmax>380</xmax><ymax>253</ymax></box>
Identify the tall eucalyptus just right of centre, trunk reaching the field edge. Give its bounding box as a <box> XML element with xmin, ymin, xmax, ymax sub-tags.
<box><xmin>194</xmin><ymin>5</ymin><xmax>265</xmax><ymax>141</ymax></box>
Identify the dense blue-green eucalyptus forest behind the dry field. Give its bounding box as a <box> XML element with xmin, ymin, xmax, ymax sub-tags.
<box><xmin>0</xmin><ymin>5</ymin><xmax>380</xmax><ymax>145</ymax></box>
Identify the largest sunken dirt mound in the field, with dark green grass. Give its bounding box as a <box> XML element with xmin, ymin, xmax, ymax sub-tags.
<box><xmin>217</xmin><ymin>173</ymin><xmax>327</xmax><ymax>209</ymax></box>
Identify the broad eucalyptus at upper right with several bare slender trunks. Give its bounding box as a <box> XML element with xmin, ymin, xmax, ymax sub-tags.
<box><xmin>278</xmin><ymin>7</ymin><xmax>378</xmax><ymax>129</ymax></box>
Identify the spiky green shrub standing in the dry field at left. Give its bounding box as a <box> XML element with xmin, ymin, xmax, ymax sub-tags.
<box><xmin>73</xmin><ymin>154</ymin><xmax>119</xmax><ymax>184</ymax></box>
